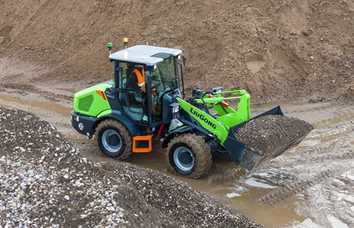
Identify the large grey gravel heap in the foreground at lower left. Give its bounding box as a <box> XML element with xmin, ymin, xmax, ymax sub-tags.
<box><xmin>0</xmin><ymin>107</ymin><xmax>259</xmax><ymax>227</ymax></box>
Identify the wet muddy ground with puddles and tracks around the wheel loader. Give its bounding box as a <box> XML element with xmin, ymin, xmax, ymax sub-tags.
<box><xmin>0</xmin><ymin>58</ymin><xmax>354</xmax><ymax>227</ymax></box>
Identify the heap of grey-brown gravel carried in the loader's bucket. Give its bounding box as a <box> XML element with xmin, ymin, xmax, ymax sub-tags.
<box><xmin>235</xmin><ymin>115</ymin><xmax>313</xmax><ymax>170</ymax></box>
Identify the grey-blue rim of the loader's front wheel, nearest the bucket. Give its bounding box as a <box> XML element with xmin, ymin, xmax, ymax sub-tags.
<box><xmin>173</xmin><ymin>146</ymin><xmax>195</xmax><ymax>172</ymax></box>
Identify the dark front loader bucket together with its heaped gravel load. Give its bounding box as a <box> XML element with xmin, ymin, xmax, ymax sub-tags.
<box><xmin>224</xmin><ymin>107</ymin><xmax>313</xmax><ymax>171</ymax></box>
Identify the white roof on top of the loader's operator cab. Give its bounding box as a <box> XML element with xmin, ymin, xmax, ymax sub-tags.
<box><xmin>109</xmin><ymin>45</ymin><xmax>182</xmax><ymax>66</ymax></box>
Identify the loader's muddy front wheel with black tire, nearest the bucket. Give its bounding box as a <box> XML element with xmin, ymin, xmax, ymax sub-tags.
<box><xmin>166</xmin><ymin>134</ymin><xmax>213</xmax><ymax>179</ymax></box>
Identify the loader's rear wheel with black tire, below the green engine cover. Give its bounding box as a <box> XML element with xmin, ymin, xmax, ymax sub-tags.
<box><xmin>95</xmin><ymin>120</ymin><xmax>131</xmax><ymax>160</ymax></box>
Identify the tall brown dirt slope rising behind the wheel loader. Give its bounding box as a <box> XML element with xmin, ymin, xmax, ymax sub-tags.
<box><xmin>0</xmin><ymin>0</ymin><xmax>354</xmax><ymax>101</ymax></box>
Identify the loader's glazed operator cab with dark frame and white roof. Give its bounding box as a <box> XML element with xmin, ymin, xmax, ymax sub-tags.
<box><xmin>109</xmin><ymin>45</ymin><xmax>183</xmax><ymax>127</ymax></box>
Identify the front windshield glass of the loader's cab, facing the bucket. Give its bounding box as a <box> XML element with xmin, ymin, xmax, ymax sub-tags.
<box><xmin>152</xmin><ymin>56</ymin><xmax>178</xmax><ymax>93</ymax></box>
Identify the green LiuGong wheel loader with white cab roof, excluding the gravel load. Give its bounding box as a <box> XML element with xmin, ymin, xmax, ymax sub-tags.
<box><xmin>72</xmin><ymin>40</ymin><xmax>308</xmax><ymax>178</ymax></box>
